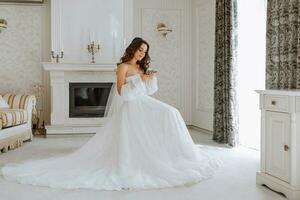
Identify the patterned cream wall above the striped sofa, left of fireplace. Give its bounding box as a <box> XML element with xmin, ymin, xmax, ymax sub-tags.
<box><xmin>0</xmin><ymin>0</ymin><xmax>50</xmax><ymax>126</ymax></box>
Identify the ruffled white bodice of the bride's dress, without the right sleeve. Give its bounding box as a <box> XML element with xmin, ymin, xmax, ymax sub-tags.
<box><xmin>121</xmin><ymin>76</ymin><xmax>146</xmax><ymax>101</ymax></box>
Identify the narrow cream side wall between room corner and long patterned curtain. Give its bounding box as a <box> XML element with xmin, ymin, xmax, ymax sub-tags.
<box><xmin>192</xmin><ymin>0</ymin><xmax>215</xmax><ymax>131</ymax></box>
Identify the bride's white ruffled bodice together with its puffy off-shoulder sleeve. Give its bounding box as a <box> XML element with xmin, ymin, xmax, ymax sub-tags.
<box><xmin>121</xmin><ymin>74</ymin><xmax>158</xmax><ymax>101</ymax></box>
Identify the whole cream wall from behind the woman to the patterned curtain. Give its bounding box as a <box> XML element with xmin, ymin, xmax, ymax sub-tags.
<box><xmin>134</xmin><ymin>0</ymin><xmax>215</xmax><ymax>128</ymax></box>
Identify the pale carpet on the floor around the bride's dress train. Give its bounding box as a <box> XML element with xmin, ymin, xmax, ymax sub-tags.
<box><xmin>0</xmin><ymin>129</ymin><xmax>285</xmax><ymax>200</ymax></box>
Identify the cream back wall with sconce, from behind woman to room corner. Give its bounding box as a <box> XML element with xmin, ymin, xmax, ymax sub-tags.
<box><xmin>133</xmin><ymin>0</ymin><xmax>192</xmax><ymax>124</ymax></box>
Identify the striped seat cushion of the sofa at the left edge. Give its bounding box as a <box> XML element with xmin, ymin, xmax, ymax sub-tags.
<box><xmin>0</xmin><ymin>108</ymin><xmax>28</xmax><ymax>128</ymax></box>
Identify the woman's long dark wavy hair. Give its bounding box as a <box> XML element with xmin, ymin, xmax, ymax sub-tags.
<box><xmin>117</xmin><ymin>37</ymin><xmax>151</xmax><ymax>72</ymax></box>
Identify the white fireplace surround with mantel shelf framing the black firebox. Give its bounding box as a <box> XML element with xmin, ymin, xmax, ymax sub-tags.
<box><xmin>43</xmin><ymin>63</ymin><xmax>116</xmax><ymax>135</ymax></box>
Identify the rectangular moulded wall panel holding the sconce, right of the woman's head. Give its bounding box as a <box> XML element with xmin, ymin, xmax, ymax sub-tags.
<box><xmin>141</xmin><ymin>8</ymin><xmax>181</xmax><ymax>109</ymax></box>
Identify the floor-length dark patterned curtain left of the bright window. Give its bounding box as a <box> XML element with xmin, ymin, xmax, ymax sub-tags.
<box><xmin>213</xmin><ymin>0</ymin><xmax>238</xmax><ymax>146</ymax></box>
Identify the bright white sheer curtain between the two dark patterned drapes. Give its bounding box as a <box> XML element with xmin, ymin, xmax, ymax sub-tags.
<box><xmin>237</xmin><ymin>0</ymin><xmax>267</xmax><ymax>149</ymax></box>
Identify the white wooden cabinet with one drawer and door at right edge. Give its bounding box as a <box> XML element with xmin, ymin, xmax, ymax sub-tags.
<box><xmin>256</xmin><ymin>90</ymin><xmax>300</xmax><ymax>200</ymax></box>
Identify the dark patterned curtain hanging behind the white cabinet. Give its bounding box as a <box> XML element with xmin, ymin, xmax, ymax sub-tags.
<box><xmin>266</xmin><ymin>0</ymin><xmax>300</xmax><ymax>89</ymax></box>
